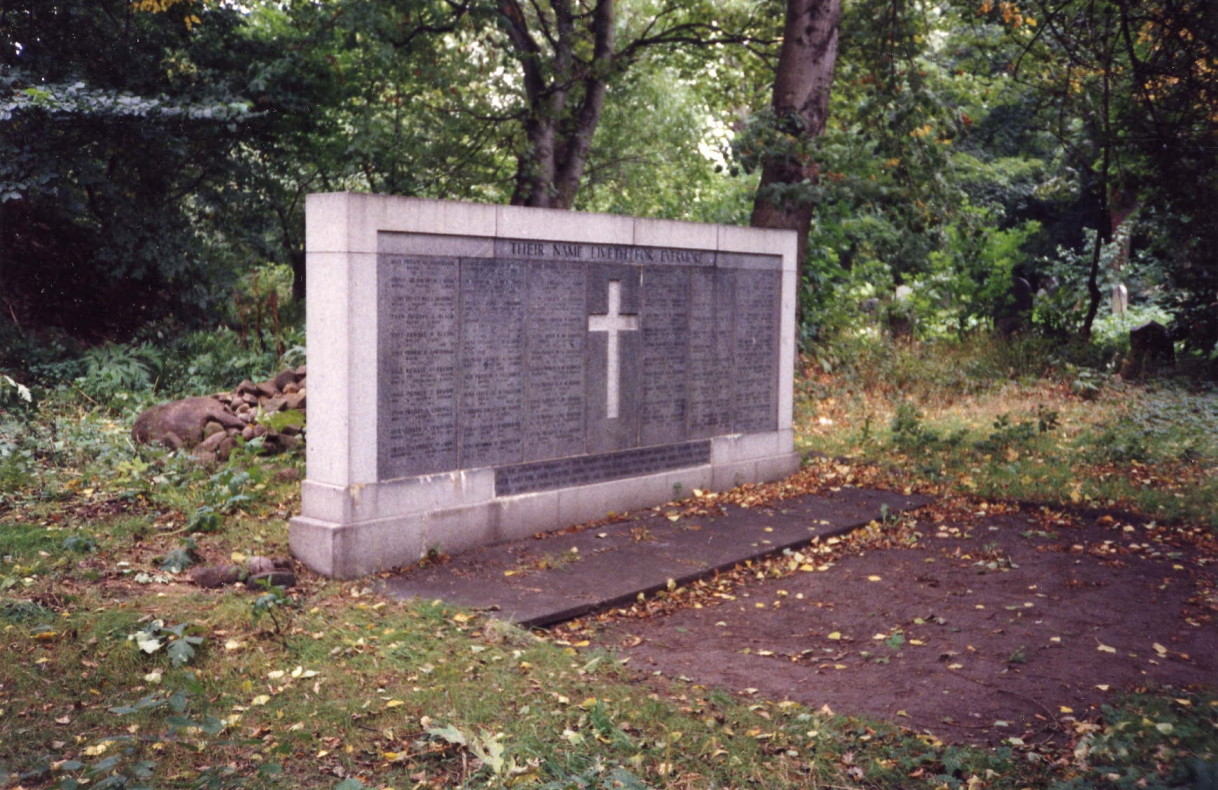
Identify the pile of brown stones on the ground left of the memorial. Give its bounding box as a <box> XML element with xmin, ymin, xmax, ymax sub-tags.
<box><xmin>132</xmin><ymin>365</ymin><xmax>307</xmax><ymax>464</ymax></box>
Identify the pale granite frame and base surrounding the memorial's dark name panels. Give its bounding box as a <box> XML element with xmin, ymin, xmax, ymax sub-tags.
<box><xmin>289</xmin><ymin>192</ymin><xmax>799</xmax><ymax>578</ymax></box>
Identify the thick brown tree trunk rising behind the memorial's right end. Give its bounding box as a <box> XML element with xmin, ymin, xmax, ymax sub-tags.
<box><xmin>750</xmin><ymin>0</ymin><xmax>842</xmax><ymax>305</ymax></box>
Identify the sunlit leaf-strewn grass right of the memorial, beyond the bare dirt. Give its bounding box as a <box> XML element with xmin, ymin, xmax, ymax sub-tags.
<box><xmin>797</xmin><ymin>335</ymin><xmax>1218</xmax><ymax>527</ymax></box>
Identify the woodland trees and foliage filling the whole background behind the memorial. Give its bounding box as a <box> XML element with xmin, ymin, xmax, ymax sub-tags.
<box><xmin>0</xmin><ymin>0</ymin><xmax>1218</xmax><ymax>364</ymax></box>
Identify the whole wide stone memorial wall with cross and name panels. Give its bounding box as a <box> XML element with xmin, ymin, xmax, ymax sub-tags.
<box><xmin>290</xmin><ymin>194</ymin><xmax>799</xmax><ymax>577</ymax></box>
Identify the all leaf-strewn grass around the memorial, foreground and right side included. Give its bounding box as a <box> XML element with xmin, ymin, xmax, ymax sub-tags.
<box><xmin>0</xmin><ymin>335</ymin><xmax>1218</xmax><ymax>790</ymax></box>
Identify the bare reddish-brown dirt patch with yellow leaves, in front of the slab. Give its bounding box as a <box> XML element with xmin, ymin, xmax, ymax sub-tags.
<box><xmin>590</xmin><ymin>508</ymin><xmax>1218</xmax><ymax>745</ymax></box>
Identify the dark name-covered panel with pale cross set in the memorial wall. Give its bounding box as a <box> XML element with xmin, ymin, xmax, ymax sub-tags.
<box><xmin>379</xmin><ymin>233</ymin><xmax>780</xmax><ymax>484</ymax></box>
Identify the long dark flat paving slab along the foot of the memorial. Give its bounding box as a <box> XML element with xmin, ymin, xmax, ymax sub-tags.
<box><xmin>384</xmin><ymin>488</ymin><xmax>931</xmax><ymax>627</ymax></box>
